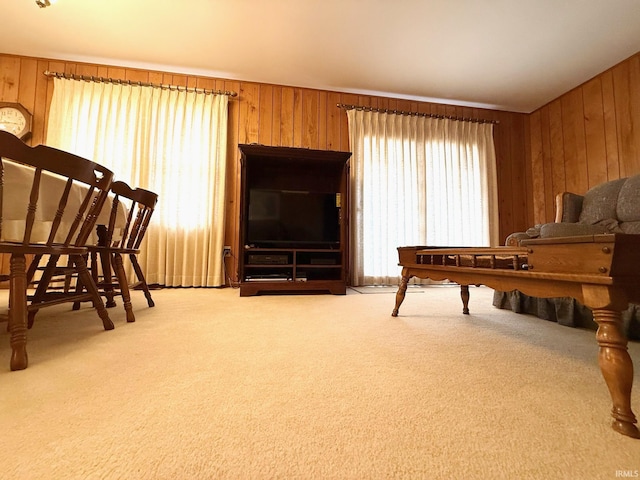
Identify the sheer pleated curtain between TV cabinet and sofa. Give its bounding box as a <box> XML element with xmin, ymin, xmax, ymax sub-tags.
<box><xmin>347</xmin><ymin>109</ymin><xmax>499</xmax><ymax>285</ymax></box>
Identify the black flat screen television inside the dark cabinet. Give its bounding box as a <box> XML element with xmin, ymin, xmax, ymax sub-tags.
<box><xmin>245</xmin><ymin>188</ymin><xmax>340</xmax><ymax>248</ymax></box>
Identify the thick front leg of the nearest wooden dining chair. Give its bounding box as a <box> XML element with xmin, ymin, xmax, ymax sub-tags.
<box><xmin>9</xmin><ymin>254</ymin><xmax>29</xmax><ymax>370</ymax></box>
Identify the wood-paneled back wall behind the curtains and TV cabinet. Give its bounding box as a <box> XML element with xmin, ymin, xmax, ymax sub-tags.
<box><xmin>0</xmin><ymin>54</ymin><xmax>532</xmax><ymax>284</ymax></box>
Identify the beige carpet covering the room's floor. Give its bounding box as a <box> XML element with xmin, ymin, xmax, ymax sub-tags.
<box><xmin>0</xmin><ymin>287</ymin><xmax>640</xmax><ymax>480</ymax></box>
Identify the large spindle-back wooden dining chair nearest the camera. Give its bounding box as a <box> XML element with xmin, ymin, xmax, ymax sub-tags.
<box><xmin>0</xmin><ymin>131</ymin><xmax>114</xmax><ymax>370</ymax></box>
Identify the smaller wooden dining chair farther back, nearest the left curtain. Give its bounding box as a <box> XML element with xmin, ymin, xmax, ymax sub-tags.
<box><xmin>74</xmin><ymin>181</ymin><xmax>158</xmax><ymax>322</ymax></box>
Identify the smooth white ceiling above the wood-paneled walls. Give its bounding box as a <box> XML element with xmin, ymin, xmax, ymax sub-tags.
<box><xmin>0</xmin><ymin>0</ymin><xmax>640</xmax><ymax>112</ymax></box>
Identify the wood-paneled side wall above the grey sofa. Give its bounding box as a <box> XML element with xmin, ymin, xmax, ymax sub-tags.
<box><xmin>526</xmin><ymin>53</ymin><xmax>640</xmax><ymax>224</ymax></box>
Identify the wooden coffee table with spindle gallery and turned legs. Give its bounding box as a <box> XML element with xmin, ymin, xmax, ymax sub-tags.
<box><xmin>392</xmin><ymin>234</ymin><xmax>640</xmax><ymax>438</ymax></box>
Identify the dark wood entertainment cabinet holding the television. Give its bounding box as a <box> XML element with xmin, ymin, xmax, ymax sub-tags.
<box><xmin>237</xmin><ymin>145</ymin><xmax>351</xmax><ymax>296</ymax></box>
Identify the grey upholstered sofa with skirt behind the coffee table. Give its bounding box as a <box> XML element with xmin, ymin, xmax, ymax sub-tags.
<box><xmin>493</xmin><ymin>175</ymin><xmax>640</xmax><ymax>340</ymax></box>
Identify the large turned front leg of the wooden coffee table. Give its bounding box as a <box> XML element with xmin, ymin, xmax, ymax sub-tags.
<box><xmin>593</xmin><ymin>309</ymin><xmax>640</xmax><ymax>438</ymax></box>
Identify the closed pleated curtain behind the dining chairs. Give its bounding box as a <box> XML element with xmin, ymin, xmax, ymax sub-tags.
<box><xmin>47</xmin><ymin>78</ymin><xmax>228</xmax><ymax>287</ymax></box>
